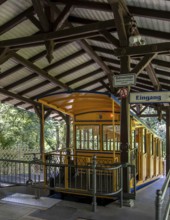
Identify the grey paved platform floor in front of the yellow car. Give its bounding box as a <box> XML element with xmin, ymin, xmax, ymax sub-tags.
<box><xmin>0</xmin><ymin>178</ymin><xmax>165</xmax><ymax>220</ymax></box>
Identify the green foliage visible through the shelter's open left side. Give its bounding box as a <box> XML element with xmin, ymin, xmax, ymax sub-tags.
<box><xmin>0</xmin><ymin>104</ymin><xmax>63</xmax><ymax>151</ymax></box>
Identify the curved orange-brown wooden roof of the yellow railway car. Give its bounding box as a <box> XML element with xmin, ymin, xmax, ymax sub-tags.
<box><xmin>38</xmin><ymin>91</ymin><xmax>160</xmax><ymax>138</ymax></box>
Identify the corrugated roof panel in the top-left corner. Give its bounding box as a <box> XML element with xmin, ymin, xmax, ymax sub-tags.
<box><xmin>0</xmin><ymin>0</ymin><xmax>32</xmax><ymax>25</ymax></box>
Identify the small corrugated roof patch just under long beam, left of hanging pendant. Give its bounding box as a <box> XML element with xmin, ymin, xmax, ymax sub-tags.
<box><xmin>17</xmin><ymin>45</ymin><xmax>45</xmax><ymax>59</ymax></box>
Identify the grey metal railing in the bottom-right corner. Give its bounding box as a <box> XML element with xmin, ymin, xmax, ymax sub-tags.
<box><xmin>155</xmin><ymin>170</ymin><xmax>170</xmax><ymax>220</ymax></box>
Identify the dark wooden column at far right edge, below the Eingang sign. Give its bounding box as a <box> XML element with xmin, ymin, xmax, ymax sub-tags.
<box><xmin>166</xmin><ymin>106</ymin><xmax>170</xmax><ymax>175</ymax></box>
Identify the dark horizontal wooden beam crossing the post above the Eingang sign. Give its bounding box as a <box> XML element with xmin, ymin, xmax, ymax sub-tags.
<box><xmin>114</xmin><ymin>42</ymin><xmax>170</xmax><ymax>56</ymax></box>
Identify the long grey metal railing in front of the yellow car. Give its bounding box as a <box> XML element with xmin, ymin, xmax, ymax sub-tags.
<box><xmin>0</xmin><ymin>155</ymin><xmax>123</xmax><ymax>211</ymax></box>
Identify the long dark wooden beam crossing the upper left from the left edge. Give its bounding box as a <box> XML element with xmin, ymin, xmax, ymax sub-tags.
<box><xmin>0</xmin><ymin>20</ymin><xmax>114</xmax><ymax>47</ymax></box>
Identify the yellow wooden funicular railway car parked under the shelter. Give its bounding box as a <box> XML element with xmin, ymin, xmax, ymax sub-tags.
<box><xmin>39</xmin><ymin>92</ymin><xmax>163</xmax><ymax>198</ymax></box>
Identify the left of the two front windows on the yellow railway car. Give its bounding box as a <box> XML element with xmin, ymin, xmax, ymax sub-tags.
<box><xmin>75</xmin><ymin>124</ymin><xmax>100</xmax><ymax>151</ymax></box>
